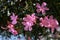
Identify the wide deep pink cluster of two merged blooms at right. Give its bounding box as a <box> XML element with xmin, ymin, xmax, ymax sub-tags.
<box><xmin>40</xmin><ymin>16</ymin><xmax>59</xmax><ymax>32</ymax></box>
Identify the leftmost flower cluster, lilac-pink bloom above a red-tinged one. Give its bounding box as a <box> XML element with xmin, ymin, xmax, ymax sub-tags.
<box><xmin>7</xmin><ymin>13</ymin><xmax>18</xmax><ymax>35</ymax></box>
